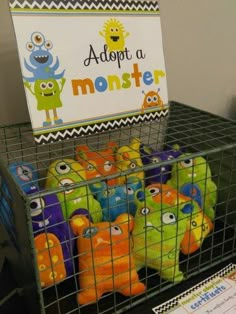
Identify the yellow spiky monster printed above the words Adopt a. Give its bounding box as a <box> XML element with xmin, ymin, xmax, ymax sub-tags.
<box><xmin>99</xmin><ymin>18</ymin><xmax>129</xmax><ymax>51</ymax></box>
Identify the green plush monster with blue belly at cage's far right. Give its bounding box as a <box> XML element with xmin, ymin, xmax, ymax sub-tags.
<box><xmin>167</xmin><ymin>154</ymin><xmax>217</xmax><ymax>220</ymax></box>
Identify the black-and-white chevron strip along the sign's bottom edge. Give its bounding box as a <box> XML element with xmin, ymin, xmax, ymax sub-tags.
<box><xmin>34</xmin><ymin>109</ymin><xmax>168</xmax><ymax>144</ymax></box>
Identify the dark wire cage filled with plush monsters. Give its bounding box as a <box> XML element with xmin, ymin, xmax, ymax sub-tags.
<box><xmin>0</xmin><ymin>102</ymin><xmax>236</xmax><ymax>314</ymax></box>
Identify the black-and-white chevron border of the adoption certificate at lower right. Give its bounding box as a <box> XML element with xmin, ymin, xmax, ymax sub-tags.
<box><xmin>152</xmin><ymin>264</ymin><xmax>236</xmax><ymax>314</ymax></box>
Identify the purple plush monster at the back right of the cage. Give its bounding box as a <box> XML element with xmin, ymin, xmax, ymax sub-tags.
<box><xmin>140</xmin><ymin>144</ymin><xmax>182</xmax><ymax>185</ymax></box>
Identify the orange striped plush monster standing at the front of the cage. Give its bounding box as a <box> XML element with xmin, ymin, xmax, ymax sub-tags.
<box><xmin>71</xmin><ymin>214</ymin><xmax>145</xmax><ymax>304</ymax></box>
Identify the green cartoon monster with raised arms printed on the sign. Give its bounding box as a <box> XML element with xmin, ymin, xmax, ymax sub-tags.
<box><xmin>24</xmin><ymin>78</ymin><xmax>66</xmax><ymax>127</ymax></box>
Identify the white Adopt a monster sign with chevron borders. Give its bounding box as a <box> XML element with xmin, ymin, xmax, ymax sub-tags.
<box><xmin>9</xmin><ymin>0</ymin><xmax>168</xmax><ymax>143</ymax></box>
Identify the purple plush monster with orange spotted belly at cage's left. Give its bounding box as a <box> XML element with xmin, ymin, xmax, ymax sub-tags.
<box><xmin>29</xmin><ymin>194</ymin><xmax>74</xmax><ymax>286</ymax></box>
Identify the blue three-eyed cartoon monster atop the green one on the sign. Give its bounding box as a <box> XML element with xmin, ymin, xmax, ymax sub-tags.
<box><xmin>23</xmin><ymin>32</ymin><xmax>65</xmax><ymax>82</ymax></box>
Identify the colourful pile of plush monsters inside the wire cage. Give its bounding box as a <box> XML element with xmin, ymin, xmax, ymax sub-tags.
<box><xmin>2</xmin><ymin>138</ymin><xmax>217</xmax><ymax>304</ymax></box>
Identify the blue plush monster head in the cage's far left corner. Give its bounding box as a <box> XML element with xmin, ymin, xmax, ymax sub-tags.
<box><xmin>8</xmin><ymin>161</ymin><xmax>39</xmax><ymax>193</ymax></box>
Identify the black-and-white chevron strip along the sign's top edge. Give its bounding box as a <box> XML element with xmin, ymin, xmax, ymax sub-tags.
<box><xmin>9</xmin><ymin>0</ymin><xmax>159</xmax><ymax>11</ymax></box>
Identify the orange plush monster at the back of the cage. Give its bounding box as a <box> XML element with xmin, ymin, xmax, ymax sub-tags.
<box><xmin>76</xmin><ymin>142</ymin><xmax>117</xmax><ymax>185</ymax></box>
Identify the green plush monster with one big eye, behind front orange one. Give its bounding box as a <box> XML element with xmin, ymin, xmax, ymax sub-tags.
<box><xmin>46</xmin><ymin>159</ymin><xmax>102</xmax><ymax>222</ymax></box>
